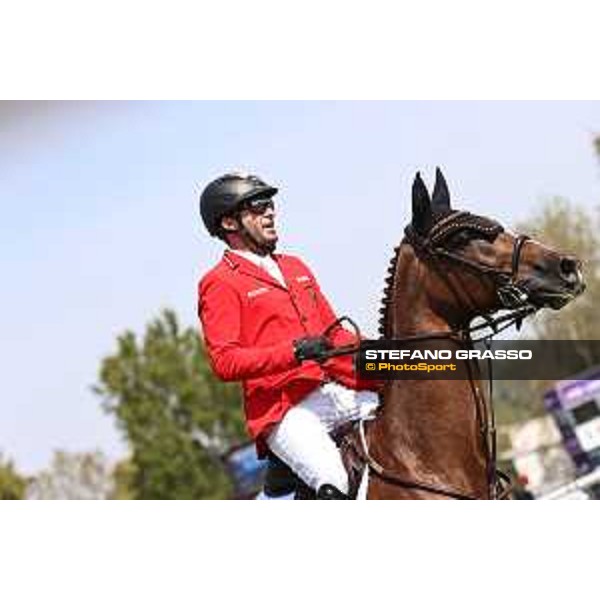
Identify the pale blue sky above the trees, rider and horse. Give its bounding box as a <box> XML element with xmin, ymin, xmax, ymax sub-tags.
<box><xmin>0</xmin><ymin>101</ymin><xmax>600</xmax><ymax>472</ymax></box>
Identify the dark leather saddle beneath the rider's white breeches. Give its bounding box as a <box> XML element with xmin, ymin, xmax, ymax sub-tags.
<box><xmin>263</xmin><ymin>421</ymin><xmax>368</xmax><ymax>500</ymax></box>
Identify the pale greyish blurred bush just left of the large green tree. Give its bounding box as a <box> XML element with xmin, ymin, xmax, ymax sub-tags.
<box><xmin>27</xmin><ymin>450</ymin><xmax>114</xmax><ymax>500</ymax></box>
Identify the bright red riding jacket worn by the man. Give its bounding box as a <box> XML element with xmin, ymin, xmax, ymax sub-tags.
<box><xmin>198</xmin><ymin>251</ymin><xmax>378</xmax><ymax>456</ymax></box>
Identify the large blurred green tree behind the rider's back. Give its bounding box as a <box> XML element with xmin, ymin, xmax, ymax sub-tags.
<box><xmin>95</xmin><ymin>310</ymin><xmax>246</xmax><ymax>499</ymax></box>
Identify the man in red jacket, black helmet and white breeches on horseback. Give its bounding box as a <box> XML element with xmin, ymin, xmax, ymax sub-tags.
<box><xmin>198</xmin><ymin>173</ymin><xmax>379</xmax><ymax>500</ymax></box>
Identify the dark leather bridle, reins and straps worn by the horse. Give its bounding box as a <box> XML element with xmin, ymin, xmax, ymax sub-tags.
<box><xmin>325</xmin><ymin>211</ymin><xmax>537</xmax><ymax>500</ymax></box>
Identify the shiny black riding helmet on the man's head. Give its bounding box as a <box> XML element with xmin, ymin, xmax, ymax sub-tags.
<box><xmin>200</xmin><ymin>173</ymin><xmax>278</xmax><ymax>236</ymax></box>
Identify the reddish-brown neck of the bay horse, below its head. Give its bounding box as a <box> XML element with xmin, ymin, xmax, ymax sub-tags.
<box><xmin>375</xmin><ymin>244</ymin><xmax>485</xmax><ymax>494</ymax></box>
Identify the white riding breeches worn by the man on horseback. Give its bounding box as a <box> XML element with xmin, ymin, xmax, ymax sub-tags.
<box><xmin>267</xmin><ymin>382</ymin><xmax>379</xmax><ymax>493</ymax></box>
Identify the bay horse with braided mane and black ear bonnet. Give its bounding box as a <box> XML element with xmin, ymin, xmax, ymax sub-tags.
<box><xmin>351</xmin><ymin>169</ymin><xmax>585</xmax><ymax>499</ymax></box>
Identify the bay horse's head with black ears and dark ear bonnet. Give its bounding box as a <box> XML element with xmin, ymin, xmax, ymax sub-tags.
<box><xmin>405</xmin><ymin>169</ymin><xmax>585</xmax><ymax>325</ymax></box>
